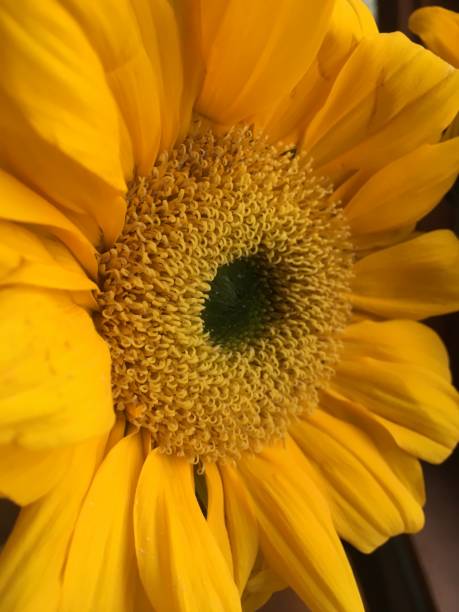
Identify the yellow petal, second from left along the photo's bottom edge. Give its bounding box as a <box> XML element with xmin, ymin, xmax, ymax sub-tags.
<box><xmin>60</xmin><ymin>434</ymin><xmax>144</xmax><ymax>612</ymax></box>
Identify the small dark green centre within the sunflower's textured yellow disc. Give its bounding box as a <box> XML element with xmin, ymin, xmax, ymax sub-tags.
<box><xmin>201</xmin><ymin>256</ymin><xmax>274</xmax><ymax>346</ymax></box>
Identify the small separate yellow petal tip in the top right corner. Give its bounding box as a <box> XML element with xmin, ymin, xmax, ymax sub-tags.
<box><xmin>408</xmin><ymin>6</ymin><xmax>459</xmax><ymax>68</ymax></box>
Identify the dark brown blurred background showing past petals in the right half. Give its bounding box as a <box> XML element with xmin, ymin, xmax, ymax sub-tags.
<box><xmin>262</xmin><ymin>0</ymin><xmax>459</xmax><ymax>612</ymax></box>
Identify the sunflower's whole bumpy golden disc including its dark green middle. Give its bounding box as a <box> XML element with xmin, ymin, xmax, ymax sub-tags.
<box><xmin>98</xmin><ymin>122</ymin><xmax>352</xmax><ymax>461</ymax></box>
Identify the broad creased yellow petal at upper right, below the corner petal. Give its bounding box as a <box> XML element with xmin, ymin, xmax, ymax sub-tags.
<box><xmin>303</xmin><ymin>33</ymin><xmax>459</xmax><ymax>185</ymax></box>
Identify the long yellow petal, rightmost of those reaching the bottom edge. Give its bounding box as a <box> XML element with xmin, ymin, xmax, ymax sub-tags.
<box><xmin>238</xmin><ymin>439</ymin><xmax>363</xmax><ymax>612</ymax></box>
